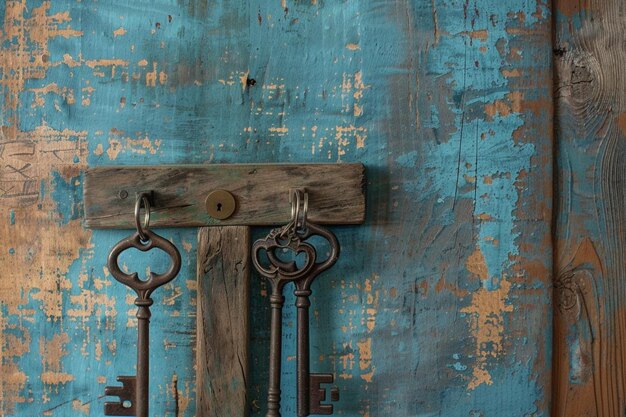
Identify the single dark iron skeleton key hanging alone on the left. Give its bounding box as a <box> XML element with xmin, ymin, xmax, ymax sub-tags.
<box><xmin>104</xmin><ymin>195</ymin><xmax>181</xmax><ymax>417</ymax></box>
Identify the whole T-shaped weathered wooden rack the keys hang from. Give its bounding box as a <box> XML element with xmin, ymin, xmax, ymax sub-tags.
<box><xmin>84</xmin><ymin>164</ymin><xmax>366</xmax><ymax>417</ymax></box>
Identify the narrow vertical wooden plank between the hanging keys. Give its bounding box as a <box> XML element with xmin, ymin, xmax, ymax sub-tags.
<box><xmin>196</xmin><ymin>226</ymin><xmax>250</xmax><ymax>417</ymax></box>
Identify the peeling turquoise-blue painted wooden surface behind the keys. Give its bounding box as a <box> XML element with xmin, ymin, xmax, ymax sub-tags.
<box><xmin>0</xmin><ymin>0</ymin><xmax>552</xmax><ymax>417</ymax></box>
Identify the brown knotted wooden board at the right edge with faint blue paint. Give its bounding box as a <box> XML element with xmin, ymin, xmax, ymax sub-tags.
<box><xmin>552</xmin><ymin>0</ymin><xmax>626</xmax><ymax>417</ymax></box>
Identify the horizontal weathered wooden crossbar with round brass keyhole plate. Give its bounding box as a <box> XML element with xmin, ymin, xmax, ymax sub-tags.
<box><xmin>84</xmin><ymin>164</ymin><xmax>365</xmax><ymax>228</ymax></box>
